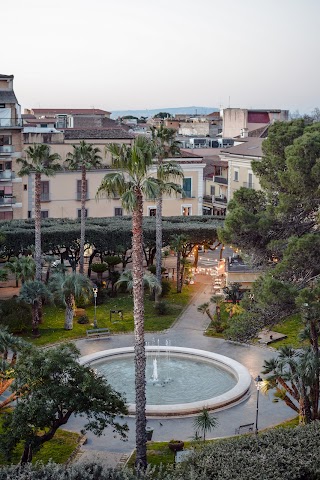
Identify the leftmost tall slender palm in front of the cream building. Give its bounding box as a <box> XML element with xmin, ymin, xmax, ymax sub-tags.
<box><xmin>17</xmin><ymin>144</ymin><xmax>61</xmax><ymax>281</ymax></box>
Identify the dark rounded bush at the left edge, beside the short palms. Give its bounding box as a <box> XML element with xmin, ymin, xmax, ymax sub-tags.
<box><xmin>0</xmin><ymin>296</ymin><xmax>32</xmax><ymax>333</ymax></box>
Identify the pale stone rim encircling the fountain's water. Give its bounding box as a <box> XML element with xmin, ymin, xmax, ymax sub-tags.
<box><xmin>79</xmin><ymin>346</ymin><xmax>252</xmax><ymax>417</ymax></box>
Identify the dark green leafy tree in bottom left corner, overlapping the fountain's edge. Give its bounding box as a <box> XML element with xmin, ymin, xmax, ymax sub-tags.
<box><xmin>0</xmin><ymin>344</ymin><xmax>128</xmax><ymax>462</ymax></box>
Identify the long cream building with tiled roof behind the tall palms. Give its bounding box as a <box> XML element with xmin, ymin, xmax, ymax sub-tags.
<box><xmin>23</xmin><ymin>127</ymin><xmax>205</xmax><ymax>218</ymax></box>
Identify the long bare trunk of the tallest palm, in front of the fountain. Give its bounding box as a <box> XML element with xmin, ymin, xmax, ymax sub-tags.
<box><xmin>132</xmin><ymin>190</ymin><xmax>147</xmax><ymax>469</ymax></box>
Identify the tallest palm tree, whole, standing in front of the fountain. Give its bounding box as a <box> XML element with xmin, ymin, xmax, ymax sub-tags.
<box><xmin>97</xmin><ymin>137</ymin><xmax>160</xmax><ymax>469</ymax></box>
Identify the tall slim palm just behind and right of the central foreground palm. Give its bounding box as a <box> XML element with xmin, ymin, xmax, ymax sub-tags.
<box><xmin>152</xmin><ymin>125</ymin><xmax>184</xmax><ymax>290</ymax></box>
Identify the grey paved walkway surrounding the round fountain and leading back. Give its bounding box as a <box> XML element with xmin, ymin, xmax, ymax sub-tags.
<box><xmin>67</xmin><ymin>275</ymin><xmax>294</xmax><ymax>464</ymax></box>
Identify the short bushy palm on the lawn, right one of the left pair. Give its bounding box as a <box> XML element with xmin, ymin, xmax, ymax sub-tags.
<box><xmin>49</xmin><ymin>273</ymin><xmax>92</xmax><ymax>330</ymax></box>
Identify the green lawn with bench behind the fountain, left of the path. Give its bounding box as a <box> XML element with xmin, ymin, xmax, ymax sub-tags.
<box><xmin>23</xmin><ymin>284</ymin><xmax>196</xmax><ymax>346</ymax></box>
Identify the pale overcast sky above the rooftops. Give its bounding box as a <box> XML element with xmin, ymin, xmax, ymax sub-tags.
<box><xmin>0</xmin><ymin>0</ymin><xmax>320</xmax><ymax>113</ymax></box>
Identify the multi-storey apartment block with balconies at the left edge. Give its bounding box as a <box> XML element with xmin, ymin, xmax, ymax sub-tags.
<box><xmin>0</xmin><ymin>74</ymin><xmax>22</xmax><ymax>220</ymax></box>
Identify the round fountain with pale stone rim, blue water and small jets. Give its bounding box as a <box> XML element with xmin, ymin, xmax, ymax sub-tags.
<box><xmin>80</xmin><ymin>346</ymin><xmax>251</xmax><ymax>416</ymax></box>
